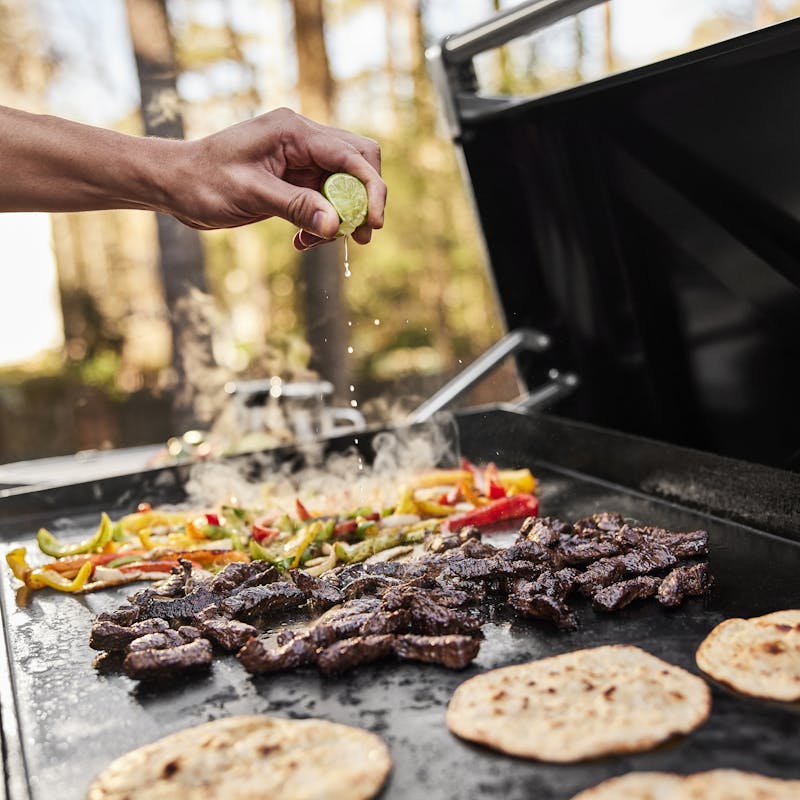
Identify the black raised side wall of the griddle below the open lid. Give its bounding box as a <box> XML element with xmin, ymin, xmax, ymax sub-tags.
<box><xmin>458</xmin><ymin>406</ymin><xmax>800</xmax><ymax>541</ymax></box>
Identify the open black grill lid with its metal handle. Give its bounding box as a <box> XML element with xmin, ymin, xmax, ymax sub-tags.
<box><xmin>429</xmin><ymin>0</ymin><xmax>800</xmax><ymax>470</ymax></box>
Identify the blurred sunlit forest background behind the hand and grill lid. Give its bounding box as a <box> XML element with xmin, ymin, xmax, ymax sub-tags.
<box><xmin>0</xmin><ymin>0</ymin><xmax>800</xmax><ymax>463</ymax></box>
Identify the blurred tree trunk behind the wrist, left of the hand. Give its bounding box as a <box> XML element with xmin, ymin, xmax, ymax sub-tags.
<box><xmin>125</xmin><ymin>0</ymin><xmax>219</xmax><ymax>432</ymax></box>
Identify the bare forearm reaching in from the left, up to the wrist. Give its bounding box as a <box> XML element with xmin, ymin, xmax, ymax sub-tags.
<box><xmin>0</xmin><ymin>106</ymin><xmax>182</xmax><ymax>211</ymax></box>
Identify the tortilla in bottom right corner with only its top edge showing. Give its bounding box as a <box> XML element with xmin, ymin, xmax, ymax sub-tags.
<box><xmin>572</xmin><ymin>769</ymin><xmax>800</xmax><ymax>800</ymax></box>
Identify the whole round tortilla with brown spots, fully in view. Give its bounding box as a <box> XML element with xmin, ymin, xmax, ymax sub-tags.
<box><xmin>447</xmin><ymin>645</ymin><xmax>711</xmax><ymax>762</ymax></box>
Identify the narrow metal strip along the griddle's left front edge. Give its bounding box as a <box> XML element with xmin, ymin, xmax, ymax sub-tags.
<box><xmin>0</xmin><ymin>574</ymin><xmax>32</xmax><ymax>800</ymax></box>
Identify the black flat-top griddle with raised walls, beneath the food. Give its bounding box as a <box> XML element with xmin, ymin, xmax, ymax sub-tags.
<box><xmin>0</xmin><ymin>407</ymin><xmax>800</xmax><ymax>800</ymax></box>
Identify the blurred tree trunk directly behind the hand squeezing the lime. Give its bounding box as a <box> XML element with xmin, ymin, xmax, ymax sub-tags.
<box><xmin>292</xmin><ymin>0</ymin><xmax>346</xmax><ymax>400</ymax></box>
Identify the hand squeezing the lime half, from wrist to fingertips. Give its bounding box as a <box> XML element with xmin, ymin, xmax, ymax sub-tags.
<box><xmin>164</xmin><ymin>108</ymin><xmax>386</xmax><ymax>250</ymax></box>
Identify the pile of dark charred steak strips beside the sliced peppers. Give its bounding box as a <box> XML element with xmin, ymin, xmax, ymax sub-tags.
<box><xmin>90</xmin><ymin>513</ymin><xmax>713</xmax><ymax>679</ymax></box>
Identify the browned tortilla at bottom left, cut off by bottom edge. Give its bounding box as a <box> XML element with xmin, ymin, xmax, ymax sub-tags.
<box><xmin>86</xmin><ymin>716</ymin><xmax>392</xmax><ymax>800</ymax></box>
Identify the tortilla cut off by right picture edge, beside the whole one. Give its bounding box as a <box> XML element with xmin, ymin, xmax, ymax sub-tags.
<box><xmin>696</xmin><ymin>609</ymin><xmax>800</xmax><ymax>702</ymax></box>
